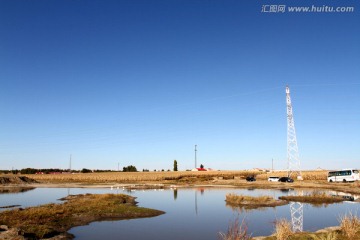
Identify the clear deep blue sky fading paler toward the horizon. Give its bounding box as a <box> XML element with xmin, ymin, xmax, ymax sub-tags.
<box><xmin>0</xmin><ymin>0</ymin><xmax>360</xmax><ymax>170</ymax></box>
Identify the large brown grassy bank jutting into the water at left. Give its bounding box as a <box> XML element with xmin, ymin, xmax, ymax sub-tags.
<box><xmin>0</xmin><ymin>194</ymin><xmax>164</xmax><ymax>239</ymax></box>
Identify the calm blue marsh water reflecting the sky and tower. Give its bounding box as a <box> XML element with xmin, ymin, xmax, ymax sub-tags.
<box><xmin>0</xmin><ymin>187</ymin><xmax>360</xmax><ymax>240</ymax></box>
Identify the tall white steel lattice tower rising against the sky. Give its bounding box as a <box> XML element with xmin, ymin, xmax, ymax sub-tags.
<box><xmin>286</xmin><ymin>86</ymin><xmax>302</xmax><ymax>179</ymax></box>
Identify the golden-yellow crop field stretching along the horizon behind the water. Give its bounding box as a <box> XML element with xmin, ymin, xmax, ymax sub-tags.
<box><xmin>27</xmin><ymin>170</ymin><xmax>327</xmax><ymax>183</ymax></box>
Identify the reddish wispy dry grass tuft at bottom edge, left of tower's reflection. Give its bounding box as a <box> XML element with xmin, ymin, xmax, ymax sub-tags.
<box><xmin>219</xmin><ymin>218</ymin><xmax>251</xmax><ymax>240</ymax></box>
